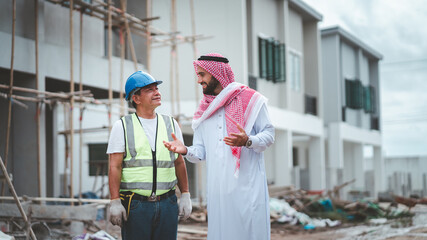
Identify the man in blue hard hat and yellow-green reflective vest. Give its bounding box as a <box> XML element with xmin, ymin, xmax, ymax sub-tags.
<box><xmin>107</xmin><ymin>71</ymin><xmax>192</xmax><ymax>239</ymax></box>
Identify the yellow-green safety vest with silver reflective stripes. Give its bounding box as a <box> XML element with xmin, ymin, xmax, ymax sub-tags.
<box><xmin>120</xmin><ymin>113</ymin><xmax>178</xmax><ymax>197</ymax></box>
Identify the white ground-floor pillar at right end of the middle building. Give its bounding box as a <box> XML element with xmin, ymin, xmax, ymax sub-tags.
<box><xmin>308</xmin><ymin>137</ymin><xmax>326</xmax><ymax>190</ymax></box>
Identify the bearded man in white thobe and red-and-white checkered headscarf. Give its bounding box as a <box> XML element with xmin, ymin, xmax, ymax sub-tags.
<box><xmin>164</xmin><ymin>53</ymin><xmax>275</xmax><ymax>240</ymax></box>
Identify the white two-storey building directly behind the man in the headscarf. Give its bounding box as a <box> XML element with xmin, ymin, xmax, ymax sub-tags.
<box><xmin>152</xmin><ymin>0</ymin><xmax>326</xmax><ymax>202</ymax></box>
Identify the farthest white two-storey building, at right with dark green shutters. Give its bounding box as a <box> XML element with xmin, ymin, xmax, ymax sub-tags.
<box><xmin>322</xmin><ymin>27</ymin><xmax>384</xmax><ymax>199</ymax></box>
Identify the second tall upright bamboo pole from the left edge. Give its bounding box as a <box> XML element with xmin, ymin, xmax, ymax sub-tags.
<box><xmin>34</xmin><ymin>0</ymin><xmax>42</xmax><ymax>197</ymax></box>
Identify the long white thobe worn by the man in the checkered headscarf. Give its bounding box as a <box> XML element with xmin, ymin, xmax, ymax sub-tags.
<box><xmin>185</xmin><ymin>104</ymin><xmax>274</xmax><ymax>240</ymax></box>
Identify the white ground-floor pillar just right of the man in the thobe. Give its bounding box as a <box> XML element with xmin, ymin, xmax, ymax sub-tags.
<box><xmin>274</xmin><ymin>131</ymin><xmax>293</xmax><ymax>186</ymax></box>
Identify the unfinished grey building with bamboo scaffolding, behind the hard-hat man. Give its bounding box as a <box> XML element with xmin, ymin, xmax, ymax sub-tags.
<box><xmin>0</xmin><ymin>0</ymin><xmax>203</xmax><ymax>236</ymax></box>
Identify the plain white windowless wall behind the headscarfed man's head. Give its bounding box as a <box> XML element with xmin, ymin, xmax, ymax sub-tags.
<box><xmin>151</xmin><ymin>0</ymin><xmax>248</xmax><ymax>104</ymax></box>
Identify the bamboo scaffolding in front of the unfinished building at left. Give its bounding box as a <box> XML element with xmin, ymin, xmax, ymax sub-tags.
<box><xmin>0</xmin><ymin>0</ymin><xmax>209</xmax><ymax>236</ymax></box>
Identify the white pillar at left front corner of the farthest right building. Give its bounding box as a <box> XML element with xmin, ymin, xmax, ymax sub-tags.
<box><xmin>327</xmin><ymin>123</ymin><xmax>344</xmax><ymax>188</ymax></box>
